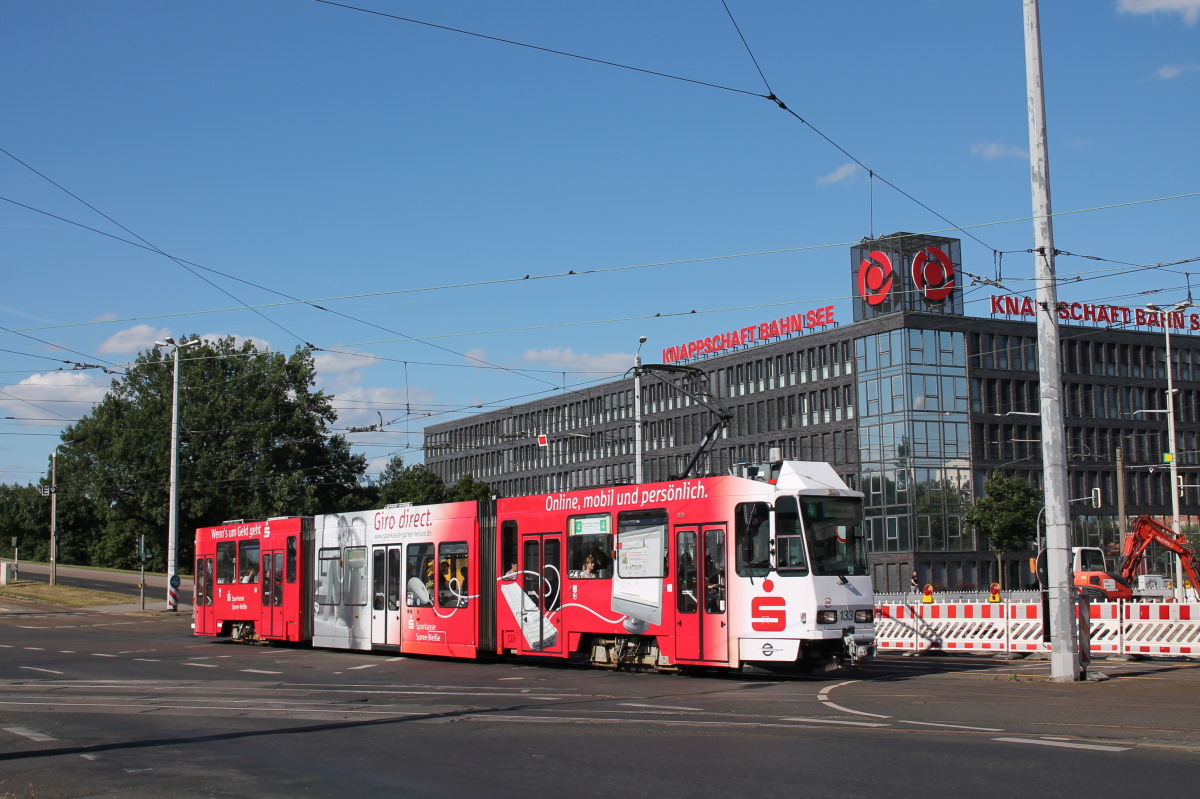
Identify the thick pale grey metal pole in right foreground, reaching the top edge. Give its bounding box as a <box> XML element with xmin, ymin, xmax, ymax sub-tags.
<box><xmin>1025</xmin><ymin>0</ymin><xmax>1082</xmax><ymax>683</ymax></box>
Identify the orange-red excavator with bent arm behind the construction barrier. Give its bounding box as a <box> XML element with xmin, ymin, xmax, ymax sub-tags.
<box><xmin>1074</xmin><ymin>516</ymin><xmax>1200</xmax><ymax>601</ymax></box>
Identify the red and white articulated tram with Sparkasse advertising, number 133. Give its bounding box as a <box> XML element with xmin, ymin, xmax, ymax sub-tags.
<box><xmin>194</xmin><ymin>461</ymin><xmax>875</xmax><ymax>671</ymax></box>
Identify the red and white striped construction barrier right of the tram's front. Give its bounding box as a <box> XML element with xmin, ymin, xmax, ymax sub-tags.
<box><xmin>875</xmin><ymin>600</ymin><xmax>1200</xmax><ymax>657</ymax></box>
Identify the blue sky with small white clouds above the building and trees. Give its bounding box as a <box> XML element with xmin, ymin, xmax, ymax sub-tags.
<box><xmin>0</xmin><ymin>0</ymin><xmax>1200</xmax><ymax>482</ymax></box>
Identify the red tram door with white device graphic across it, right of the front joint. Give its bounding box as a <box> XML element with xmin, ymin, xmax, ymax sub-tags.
<box><xmin>502</xmin><ymin>533</ymin><xmax>565</xmax><ymax>653</ymax></box>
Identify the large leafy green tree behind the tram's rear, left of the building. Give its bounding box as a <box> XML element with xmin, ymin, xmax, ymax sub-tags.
<box><xmin>51</xmin><ymin>337</ymin><xmax>366</xmax><ymax>571</ymax></box>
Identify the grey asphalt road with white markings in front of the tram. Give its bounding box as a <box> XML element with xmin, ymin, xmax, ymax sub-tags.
<box><xmin>0</xmin><ymin>573</ymin><xmax>1200</xmax><ymax>799</ymax></box>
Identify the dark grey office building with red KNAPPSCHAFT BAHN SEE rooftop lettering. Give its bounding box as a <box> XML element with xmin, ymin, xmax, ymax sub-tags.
<box><xmin>425</xmin><ymin>234</ymin><xmax>1200</xmax><ymax>591</ymax></box>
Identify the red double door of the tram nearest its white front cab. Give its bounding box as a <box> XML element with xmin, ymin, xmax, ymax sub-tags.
<box><xmin>673</xmin><ymin>525</ymin><xmax>730</xmax><ymax>663</ymax></box>
